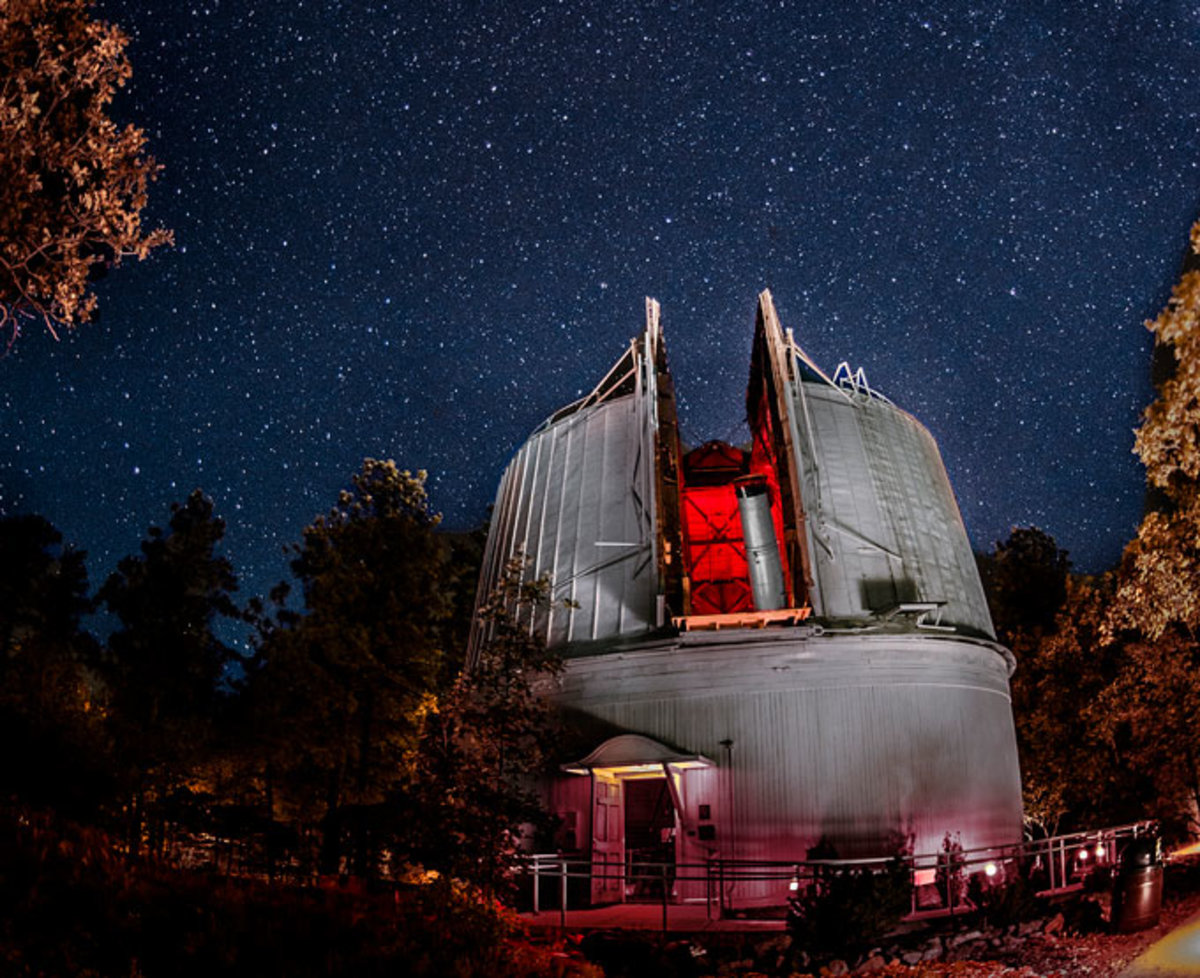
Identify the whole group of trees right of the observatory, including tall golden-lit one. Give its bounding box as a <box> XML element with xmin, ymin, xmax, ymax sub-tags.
<box><xmin>983</xmin><ymin>223</ymin><xmax>1200</xmax><ymax>838</ymax></box>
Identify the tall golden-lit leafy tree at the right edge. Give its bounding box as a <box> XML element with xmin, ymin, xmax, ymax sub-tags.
<box><xmin>1100</xmin><ymin>222</ymin><xmax>1200</xmax><ymax>830</ymax></box>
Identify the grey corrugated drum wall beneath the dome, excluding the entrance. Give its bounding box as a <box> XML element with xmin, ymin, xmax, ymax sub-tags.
<box><xmin>559</xmin><ymin>630</ymin><xmax>1021</xmax><ymax>859</ymax></box>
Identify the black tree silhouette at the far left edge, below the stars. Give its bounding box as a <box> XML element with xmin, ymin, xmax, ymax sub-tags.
<box><xmin>0</xmin><ymin>516</ymin><xmax>106</xmax><ymax>814</ymax></box>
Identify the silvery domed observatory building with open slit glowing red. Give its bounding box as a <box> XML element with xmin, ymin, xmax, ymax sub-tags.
<box><xmin>476</xmin><ymin>292</ymin><xmax>1021</xmax><ymax>904</ymax></box>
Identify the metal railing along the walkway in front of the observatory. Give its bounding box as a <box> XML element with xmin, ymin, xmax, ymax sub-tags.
<box><xmin>522</xmin><ymin>822</ymin><xmax>1157</xmax><ymax>930</ymax></box>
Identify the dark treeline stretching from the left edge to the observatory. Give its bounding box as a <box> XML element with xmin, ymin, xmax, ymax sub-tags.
<box><xmin>0</xmin><ymin>460</ymin><xmax>557</xmax><ymax>890</ymax></box>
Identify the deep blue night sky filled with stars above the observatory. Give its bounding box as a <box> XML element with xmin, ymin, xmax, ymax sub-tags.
<box><xmin>0</xmin><ymin>0</ymin><xmax>1200</xmax><ymax>624</ymax></box>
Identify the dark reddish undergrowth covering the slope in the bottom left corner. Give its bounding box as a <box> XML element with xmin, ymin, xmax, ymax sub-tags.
<box><xmin>0</xmin><ymin>811</ymin><xmax>601</xmax><ymax>978</ymax></box>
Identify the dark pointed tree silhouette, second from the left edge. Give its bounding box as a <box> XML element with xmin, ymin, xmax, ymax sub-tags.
<box><xmin>98</xmin><ymin>490</ymin><xmax>241</xmax><ymax>845</ymax></box>
